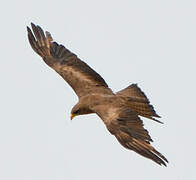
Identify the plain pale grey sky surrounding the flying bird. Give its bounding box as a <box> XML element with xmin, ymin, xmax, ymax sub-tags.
<box><xmin>0</xmin><ymin>0</ymin><xmax>196</xmax><ymax>180</ymax></box>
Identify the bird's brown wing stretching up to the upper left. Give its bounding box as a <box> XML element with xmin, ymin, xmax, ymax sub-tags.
<box><xmin>27</xmin><ymin>23</ymin><xmax>111</xmax><ymax>98</ymax></box>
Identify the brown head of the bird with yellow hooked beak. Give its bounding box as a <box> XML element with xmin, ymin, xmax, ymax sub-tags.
<box><xmin>71</xmin><ymin>103</ymin><xmax>93</xmax><ymax>120</ymax></box>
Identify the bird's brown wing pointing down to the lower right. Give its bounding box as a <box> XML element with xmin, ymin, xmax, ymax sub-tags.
<box><xmin>95</xmin><ymin>106</ymin><xmax>168</xmax><ymax>166</ymax></box>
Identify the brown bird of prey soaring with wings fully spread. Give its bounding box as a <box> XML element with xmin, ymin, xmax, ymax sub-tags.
<box><xmin>27</xmin><ymin>23</ymin><xmax>168</xmax><ymax>166</ymax></box>
